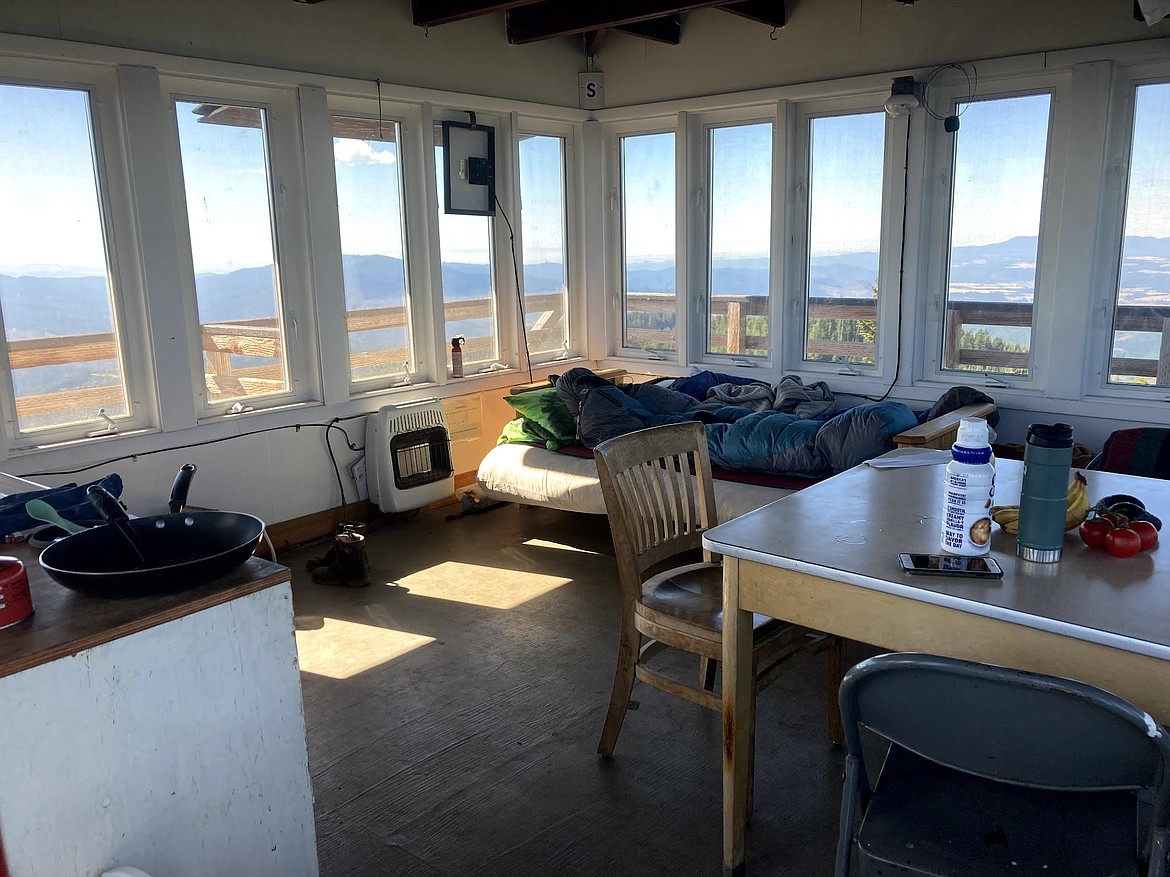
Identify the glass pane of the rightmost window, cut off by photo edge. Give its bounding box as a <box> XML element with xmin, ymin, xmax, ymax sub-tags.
<box><xmin>1109</xmin><ymin>82</ymin><xmax>1170</xmax><ymax>387</ymax></box>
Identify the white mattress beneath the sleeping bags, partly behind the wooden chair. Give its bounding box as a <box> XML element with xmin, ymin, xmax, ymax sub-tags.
<box><xmin>476</xmin><ymin>444</ymin><xmax>792</xmax><ymax>522</ymax></box>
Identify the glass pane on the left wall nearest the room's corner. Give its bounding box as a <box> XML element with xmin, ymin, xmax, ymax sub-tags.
<box><xmin>519</xmin><ymin>136</ymin><xmax>569</xmax><ymax>355</ymax></box>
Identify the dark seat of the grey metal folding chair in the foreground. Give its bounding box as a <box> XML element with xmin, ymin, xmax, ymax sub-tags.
<box><xmin>858</xmin><ymin>744</ymin><xmax>1140</xmax><ymax>877</ymax></box>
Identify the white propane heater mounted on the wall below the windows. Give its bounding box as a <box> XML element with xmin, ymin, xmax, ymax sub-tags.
<box><xmin>366</xmin><ymin>399</ymin><xmax>455</xmax><ymax>512</ymax></box>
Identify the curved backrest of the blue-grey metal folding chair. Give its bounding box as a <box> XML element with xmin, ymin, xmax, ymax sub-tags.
<box><xmin>840</xmin><ymin>654</ymin><xmax>1170</xmax><ymax>812</ymax></box>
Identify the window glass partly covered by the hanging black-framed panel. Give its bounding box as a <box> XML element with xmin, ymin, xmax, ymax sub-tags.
<box><xmin>434</xmin><ymin>124</ymin><xmax>500</xmax><ymax>374</ymax></box>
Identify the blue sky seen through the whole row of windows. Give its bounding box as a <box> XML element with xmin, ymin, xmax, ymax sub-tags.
<box><xmin>0</xmin><ymin>84</ymin><xmax>1170</xmax><ymax>274</ymax></box>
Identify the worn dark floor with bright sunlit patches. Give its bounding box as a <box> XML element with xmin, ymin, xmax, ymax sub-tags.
<box><xmin>290</xmin><ymin>505</ymin><xmax>863</xmax><ymax>877</ymax></box>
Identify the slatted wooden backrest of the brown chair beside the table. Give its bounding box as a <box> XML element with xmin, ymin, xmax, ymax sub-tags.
<box><xmin>593</xmin><ymin>423</ymin><xmax>717</xmax><ymax>587</ymax></box>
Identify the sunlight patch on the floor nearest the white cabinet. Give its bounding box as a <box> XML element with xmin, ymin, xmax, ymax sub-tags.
<box><xmin>296</xmin><ymin>617</ymin><xmax>435</xmax><ymax>679</ymax></box>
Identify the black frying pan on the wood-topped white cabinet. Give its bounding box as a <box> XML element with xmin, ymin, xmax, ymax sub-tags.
<box><xmin>41</xmin><ymin>467</ymin><xmax>264</xmax><ymax>596</ymax></box>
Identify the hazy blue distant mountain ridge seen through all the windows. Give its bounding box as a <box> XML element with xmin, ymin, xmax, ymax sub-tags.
<box><xmin>0</xmin><ymin>237</ymin><xmax>1170</xmax><ymax>338</ymax></box>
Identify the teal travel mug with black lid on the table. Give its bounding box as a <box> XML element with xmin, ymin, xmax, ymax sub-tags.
<box><xmin>1016</xmin><ymin>423</ymin><xmax>1073</xmax><ymax>564</ymax></box>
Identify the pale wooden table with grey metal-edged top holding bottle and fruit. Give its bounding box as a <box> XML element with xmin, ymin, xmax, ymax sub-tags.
<box><xmin>703</xmin><ymin>450</ymin><xmax>1170</xmax><ymax>875</ymax></box>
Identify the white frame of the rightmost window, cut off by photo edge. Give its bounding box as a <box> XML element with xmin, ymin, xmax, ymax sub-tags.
<box><xmin>1085</xmin><ymin>61</ymin><xmax>1170</xmax><ymax>402</ymax></box>
